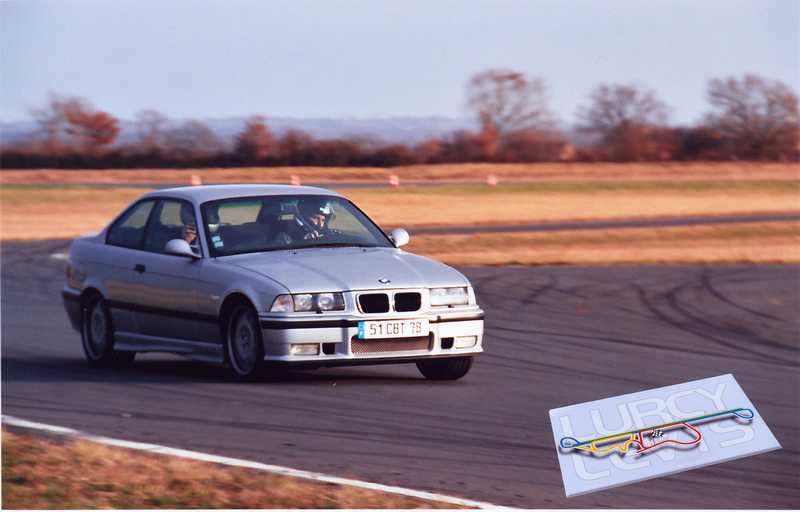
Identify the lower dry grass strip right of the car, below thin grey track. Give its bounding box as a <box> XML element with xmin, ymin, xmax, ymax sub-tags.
<box><xmin>408</xmin><ymin>222</ymin><xmax>800</xmax><ymax>265</ymax></box>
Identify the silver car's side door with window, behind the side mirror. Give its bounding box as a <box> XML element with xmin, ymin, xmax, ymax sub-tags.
<box><xmin>133</xmin><ymin>198</ymin><xmax>205</xmax><ymax>340</ymax></box>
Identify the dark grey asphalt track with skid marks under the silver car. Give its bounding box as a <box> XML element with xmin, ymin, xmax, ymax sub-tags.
<box><xmin>2</xmin><ymin>241</ymin><xmax>800</xmax><ymax>508</ymax></box>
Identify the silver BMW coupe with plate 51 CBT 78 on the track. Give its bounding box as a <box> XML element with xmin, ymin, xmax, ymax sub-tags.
<box><xmin>62</xmin><ymin>185</ymin><xmax>484</xmax><ymax>380</ymax></box>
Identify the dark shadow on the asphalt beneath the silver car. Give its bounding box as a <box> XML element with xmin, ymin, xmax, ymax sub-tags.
<box><xmin>2</xmin><ymin>356</ymin><xmax>427</xmax><ymax>385</ymax></box>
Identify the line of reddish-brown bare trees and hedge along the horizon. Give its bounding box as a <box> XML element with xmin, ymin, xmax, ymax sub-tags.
<box><xmin>0</xmin><ymin>70</ymin><xmax>800</xmax><ymax>168</ymax></box>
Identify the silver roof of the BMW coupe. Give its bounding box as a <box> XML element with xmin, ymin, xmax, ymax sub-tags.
<box><xmin>143</xmin><ymin>184</ymin><xmax>342</xmax><ymax>204</ymax></box>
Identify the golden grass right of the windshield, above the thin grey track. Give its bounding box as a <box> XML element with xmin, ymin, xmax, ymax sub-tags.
<box><xmin>343</xmin><ymin>181</ymin><xmax>800</xmax><ymax>227</ymax></box>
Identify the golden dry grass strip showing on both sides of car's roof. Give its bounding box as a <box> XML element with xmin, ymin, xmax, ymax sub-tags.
<box><xmin>0</xmin><ymin>180</ymin><xmax>800</xmax><ymax>240</ymax></box>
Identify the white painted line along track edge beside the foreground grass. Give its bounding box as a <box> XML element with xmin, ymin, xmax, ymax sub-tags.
<box><xmin>2</xmin><ymin>414</ymin><xmax>509</xmax><ymax>510</ymax></box>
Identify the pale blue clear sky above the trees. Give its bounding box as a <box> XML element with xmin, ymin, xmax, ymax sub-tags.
<box><xmin>0</xmin><ymin>0</ymin><xmax>800</xmax><ymax>123</ymax></box>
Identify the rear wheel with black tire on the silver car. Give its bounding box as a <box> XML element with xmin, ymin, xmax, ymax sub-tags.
<box><xmin>81</xmin><ymin>295</ymin><xmax>136</xmax><ymax>368</ymax></box>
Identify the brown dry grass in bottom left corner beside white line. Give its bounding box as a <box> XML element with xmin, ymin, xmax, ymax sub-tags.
<box><xmin>2</xmin><ymin>430</ymin><xmax>454</xmax><ymax>509</ymax></box>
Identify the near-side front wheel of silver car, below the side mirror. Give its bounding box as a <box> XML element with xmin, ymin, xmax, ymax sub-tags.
<box><xmin>225</xmin><ymin>304</ymin><xmax>264</xmax><ymax>381</ymax></box>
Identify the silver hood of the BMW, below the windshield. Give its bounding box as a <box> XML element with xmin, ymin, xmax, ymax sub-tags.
<box><xmin>224</xmin><ymin>247</ymin><xmax>469</xmax><ymax>293</ymax></box>
